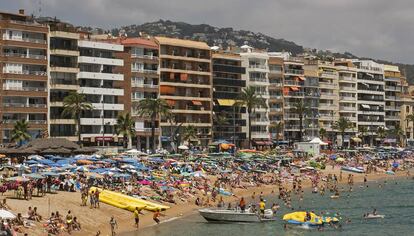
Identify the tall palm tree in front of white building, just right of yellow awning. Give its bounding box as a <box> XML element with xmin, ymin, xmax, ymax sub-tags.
<box><xmin>235</xmin><ymin>87</ymin><xmax>267</xmax><ymax>148</ymax></box>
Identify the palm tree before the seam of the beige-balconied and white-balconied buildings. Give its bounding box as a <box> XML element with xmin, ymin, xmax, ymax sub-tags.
<box><xmin>62</xmin><ymin>92</ymin><xmax>93</xmax><ymax>145</ymax></box>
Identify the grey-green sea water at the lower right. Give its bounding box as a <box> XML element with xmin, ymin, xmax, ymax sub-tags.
<box><xmin>125</xmin><ymin>178</ymin><xmax>414</xmax><ymax>236</ymax></box>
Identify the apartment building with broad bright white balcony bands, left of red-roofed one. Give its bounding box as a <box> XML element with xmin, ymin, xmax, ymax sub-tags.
<box><xmin>77</xmin><ymin>35</ymin><xmax>125</xmax><ymax>145</ymax></box>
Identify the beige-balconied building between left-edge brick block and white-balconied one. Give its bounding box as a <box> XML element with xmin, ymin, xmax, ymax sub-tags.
<box><xmin>45</xmin><ymin>21</ymin><xmax>80</xmax><ymax>141</ymax></box>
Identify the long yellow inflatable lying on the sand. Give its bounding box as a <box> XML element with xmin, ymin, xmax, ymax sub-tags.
<box><xmin>89</xmin><ymin>187</ymin><xmax>170</xmax><ymax>212</ymax></box>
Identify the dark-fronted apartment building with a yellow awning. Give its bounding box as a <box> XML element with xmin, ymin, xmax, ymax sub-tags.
<box><xmin>212</xmin><ymin>51</ymin><xmax>247</xmax><ymax>147</ymax></box>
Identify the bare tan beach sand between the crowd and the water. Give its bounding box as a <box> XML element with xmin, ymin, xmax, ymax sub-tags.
<box><xmin>3</xmin><ymin>167</ymin><xmax>406</xmax><ymax>235</ymax></box>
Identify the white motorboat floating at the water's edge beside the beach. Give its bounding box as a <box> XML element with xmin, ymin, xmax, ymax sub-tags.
<box><xmin>198</xmin><ymin>208</ymin><xmax>273</xmax><ymax>222</ymax></box>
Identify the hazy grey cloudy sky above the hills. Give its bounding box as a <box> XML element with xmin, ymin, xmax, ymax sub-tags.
<box><xmin>0</xmin><ymin>0</ymin><xmax>414</xmax><ymax>64</ymax></box>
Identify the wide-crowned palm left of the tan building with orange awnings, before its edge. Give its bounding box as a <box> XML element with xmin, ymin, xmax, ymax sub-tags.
<box><xmin>136</xmin><ymin>98</ymin><xmax>171</xmax><ymax>153</ymax></box>
